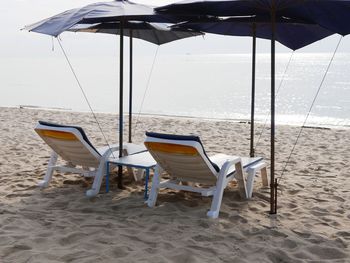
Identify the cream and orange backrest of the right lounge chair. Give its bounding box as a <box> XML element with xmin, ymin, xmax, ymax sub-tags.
<box><xmin>145</xmin><ymin>132</ymin><xmax>219</xmax><ymax>184</ymax></box>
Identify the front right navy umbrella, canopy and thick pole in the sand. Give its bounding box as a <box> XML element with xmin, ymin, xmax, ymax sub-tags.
<box><xmin>156</xmin><ymin>0</ymin><xmax>350</xmax><ymax>214</ymax></box>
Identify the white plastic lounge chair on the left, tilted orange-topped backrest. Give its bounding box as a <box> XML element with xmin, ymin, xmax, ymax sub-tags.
<box><xmin>35</xmin><ymin>121</ymin><xmax>146</xmax><ymax>197</ymax></box>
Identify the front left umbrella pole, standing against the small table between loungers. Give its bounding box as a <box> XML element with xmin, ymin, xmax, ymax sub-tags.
<box><xmin>118</xmin><ymin>20</ymin><xmax>124</xmax><ymax>189</ymax></box>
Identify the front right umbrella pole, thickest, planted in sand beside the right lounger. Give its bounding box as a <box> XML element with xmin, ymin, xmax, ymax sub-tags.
<box><xmin>270</xmin><ymin>1</ymin><xmax>277</xmax><ymax>214</ymax></box>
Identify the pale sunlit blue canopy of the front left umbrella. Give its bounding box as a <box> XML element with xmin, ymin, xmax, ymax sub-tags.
<box><xmin>24</xmin><ymin>0</ymin><xmax>179</xmax><ymax>37</ymax></box>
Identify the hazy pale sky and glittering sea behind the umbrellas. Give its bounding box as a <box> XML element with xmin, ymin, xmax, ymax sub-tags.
<box><xmin>0</xmin><ymin>0</ymin><xmax>350</xmax><ymax>127</ymax></box>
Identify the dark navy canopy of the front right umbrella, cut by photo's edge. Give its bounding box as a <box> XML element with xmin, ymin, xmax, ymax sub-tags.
<box><xmin>156</xmin><ymin>0</ymin><xmax>350</xmax><ymax>35</ymax></box>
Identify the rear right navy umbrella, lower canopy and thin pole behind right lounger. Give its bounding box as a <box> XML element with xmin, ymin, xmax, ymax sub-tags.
<box><xmin>172</xmin><ymin>15</ymin><xmax>333</xmax><ymax>157</ymax></box>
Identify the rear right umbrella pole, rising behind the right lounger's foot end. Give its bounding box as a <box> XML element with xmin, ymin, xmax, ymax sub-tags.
<box><xmin>249</xmin><ymin>23</ymin><xmax>256</xmax><ymax>157</ymax></box>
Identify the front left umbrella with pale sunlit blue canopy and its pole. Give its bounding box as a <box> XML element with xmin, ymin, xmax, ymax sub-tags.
<box><xmin>24</xmin><ymin>0</ymin><xmax>190</xmax><ymax>188</ymax></box>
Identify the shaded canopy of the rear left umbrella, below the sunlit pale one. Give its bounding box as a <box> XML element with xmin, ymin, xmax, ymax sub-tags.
<box><xmin>68</xmin><ymin>21</ymin><xmax>203</xmax><ymax>45</ymax></box>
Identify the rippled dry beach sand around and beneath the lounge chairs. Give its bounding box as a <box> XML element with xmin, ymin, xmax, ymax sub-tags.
<box><xmin>0</xmin><ymin>108</ymin><xmax>350</xmax><ymax>263</ymax></box>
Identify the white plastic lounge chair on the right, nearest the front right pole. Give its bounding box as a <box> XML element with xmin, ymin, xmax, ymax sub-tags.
<box><xmin>145</xmin><ymin>132</ymin><xmax>268</xmax><ymax>218</ymax></box>
